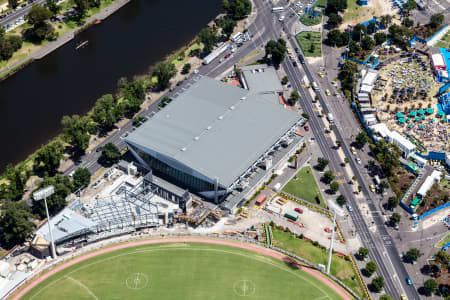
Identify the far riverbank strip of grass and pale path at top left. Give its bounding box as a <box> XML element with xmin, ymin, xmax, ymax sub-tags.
<box><xmin>0</xmin><ymin>0</ymin><xmax>131</xmax><ymax>81</ymax></box>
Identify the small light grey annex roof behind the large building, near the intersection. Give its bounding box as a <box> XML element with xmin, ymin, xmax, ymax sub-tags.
<box><xmin>241</xmin><ymin>64</ymin><xmax>283</xmax><ymax>94</ymax></box>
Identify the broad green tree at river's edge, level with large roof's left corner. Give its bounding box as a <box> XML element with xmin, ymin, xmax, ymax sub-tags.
<box><xmin>61</xmin><ymin>115</ymin><xmax>94</xmax><ymax>153</ymax></box>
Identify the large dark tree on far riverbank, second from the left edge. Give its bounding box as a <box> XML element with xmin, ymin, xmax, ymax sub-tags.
<box><xmin>26</xmin><ymin>5</ymin><xmax>56</xmax><ymax>40</ymax></box>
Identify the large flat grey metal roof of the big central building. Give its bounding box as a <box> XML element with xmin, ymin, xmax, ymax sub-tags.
<box><xmin>126</xmin><ymin>77</ymin><xmax>301</xmax><ymax>187</ymax></box>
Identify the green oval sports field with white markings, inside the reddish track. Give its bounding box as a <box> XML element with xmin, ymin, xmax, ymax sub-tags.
<box><xmin>14</xmin><ymin>241</ymin><xmax>351</xmax><ymax>300</ymax></box>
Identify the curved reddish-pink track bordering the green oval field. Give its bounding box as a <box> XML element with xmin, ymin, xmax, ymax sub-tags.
<box><xmin>8</xmin><ymin>237</ymin><xmax>353</xmax><ymax>300</ymax></box>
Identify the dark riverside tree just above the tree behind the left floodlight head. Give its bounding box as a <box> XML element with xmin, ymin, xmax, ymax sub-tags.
<box><xmin>33</xmin><ymin>141</ymin><xmax>64</xmax><ymax>176</ymax></box>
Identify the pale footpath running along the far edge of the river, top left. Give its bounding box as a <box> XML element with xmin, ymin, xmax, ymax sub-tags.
<box><xmin>0</xmin><ymin>0</ymin><xmax>131</xmax><ymax>78</ymax></box>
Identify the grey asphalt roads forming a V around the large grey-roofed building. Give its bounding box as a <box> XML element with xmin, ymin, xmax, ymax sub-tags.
<box><xmin>60</xmin><ymin>0</ymin><xmax>420</xmax><ymax>299</ymax></box>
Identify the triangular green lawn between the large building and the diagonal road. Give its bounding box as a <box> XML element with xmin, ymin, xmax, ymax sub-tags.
<box><xmin>283</xmin><ymin>167</ymin><xmax>327</xmax><ymax>208</ymax></box>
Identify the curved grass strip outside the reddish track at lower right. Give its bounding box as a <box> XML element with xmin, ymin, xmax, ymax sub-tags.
<box><xmin>272</xmin><ymin>228</ymin><xmax>363</xmax><ymax>299</ymax></box>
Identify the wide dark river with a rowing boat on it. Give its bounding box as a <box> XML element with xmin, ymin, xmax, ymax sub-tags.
<box><xmin>0</xmin><ymin>0</ymin><xmax>221</xmax><ymax>171</ymax></box>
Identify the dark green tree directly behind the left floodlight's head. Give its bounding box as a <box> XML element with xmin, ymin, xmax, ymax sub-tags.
<box><xmin>33</xmin><ymin>174</ymin><xmax>73</xmax><ymax>219</ymax></box>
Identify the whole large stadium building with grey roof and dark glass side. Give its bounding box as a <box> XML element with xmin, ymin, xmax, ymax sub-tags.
<box><xmin>125</xmin><ymin>69</ymin><xmax>304</xmax><ymax>210</ymax></box>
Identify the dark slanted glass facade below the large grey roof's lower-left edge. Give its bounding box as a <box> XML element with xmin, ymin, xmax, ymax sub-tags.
<box><xmin>128</xmin><ymin>145</ymin><xmax>214</xmax><ymax>193</ymax></box>
